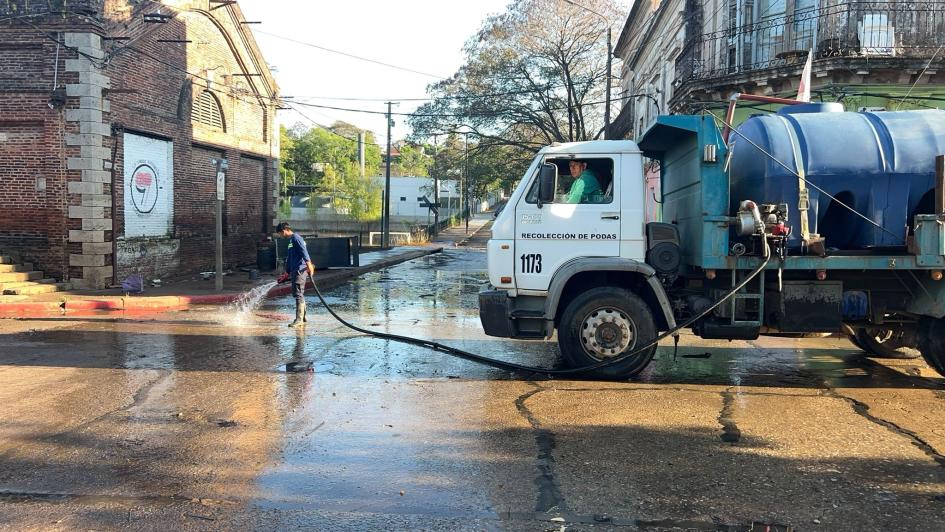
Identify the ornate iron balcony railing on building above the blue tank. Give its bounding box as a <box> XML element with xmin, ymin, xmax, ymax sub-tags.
<box><xmin>676</xmin><ymin>0</ymin><xmax>945</xmax><ymax>83</ymax></box>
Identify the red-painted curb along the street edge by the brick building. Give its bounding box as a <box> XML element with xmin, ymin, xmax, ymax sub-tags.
<box><xmin>0</xmin><ymin>247</ymin><xmax>443</xmax><ymax>318</ymax></box>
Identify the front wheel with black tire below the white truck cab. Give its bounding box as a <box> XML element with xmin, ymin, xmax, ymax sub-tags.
<box><xmin>558</xmin><ymin>286</ymin><xmax>657</xmax><ymax>379</ymax></box>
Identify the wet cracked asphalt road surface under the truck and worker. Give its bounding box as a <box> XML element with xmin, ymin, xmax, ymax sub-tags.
<box><xmin>0</xmin><ymin>239</ymin><xmax>945</xmax><ymax>530</ymax></box>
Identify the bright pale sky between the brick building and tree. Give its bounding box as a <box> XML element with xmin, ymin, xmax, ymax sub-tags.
<box><xmin>239</xmin><ymin>0</ymin><xmax>509</xmax><ymax>144</ymax></box>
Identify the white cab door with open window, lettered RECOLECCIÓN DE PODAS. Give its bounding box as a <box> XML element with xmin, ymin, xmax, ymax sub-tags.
<box><xmin>515</xmin><ymin>154</ymin><xmax>620</xmax><ymax>290</ymax></box>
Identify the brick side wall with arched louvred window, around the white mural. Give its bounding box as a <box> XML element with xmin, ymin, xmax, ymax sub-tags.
<box><xmin>110</xmin><ymin>3</ymin><xmax>275</xmax><ymax>275</ymax></box>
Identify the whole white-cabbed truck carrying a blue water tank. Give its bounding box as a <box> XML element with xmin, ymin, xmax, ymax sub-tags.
<box><xmin>479</xmin><ymin>100</ymin><xmax>945</xmax><ymax>379</ymax></box>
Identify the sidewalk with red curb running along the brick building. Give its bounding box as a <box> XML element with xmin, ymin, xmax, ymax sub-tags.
<box><xmin>0</xmin><ymin>245</ymin><xmax>442</xmax><ymax>318</ymax></box>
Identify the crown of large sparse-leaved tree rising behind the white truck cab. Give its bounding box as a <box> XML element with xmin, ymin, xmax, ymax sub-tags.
<box><xmin>410</xmin><ymin>0</ymin><xmax>623</xmax><ymax>145</ymax></box>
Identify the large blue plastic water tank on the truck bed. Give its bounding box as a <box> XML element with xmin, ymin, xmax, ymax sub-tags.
<box><xmin>730</xmin><ymin>108</ymin><xmax>945</xmax><ymax>250</ymax></box>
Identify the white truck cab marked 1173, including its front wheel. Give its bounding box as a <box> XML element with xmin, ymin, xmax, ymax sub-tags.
<box><xmin>479</xmin><ymin>140</ymin><xmax>674</xmax><ymax>376</ymax></box>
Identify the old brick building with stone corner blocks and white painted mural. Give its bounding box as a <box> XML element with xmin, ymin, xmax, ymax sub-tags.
<box><xmin>0</xmin><ymin>0</ymin><xmax>279</xmax><ymax>288</ymax></box>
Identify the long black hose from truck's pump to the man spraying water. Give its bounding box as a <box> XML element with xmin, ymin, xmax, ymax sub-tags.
<box><xmin>312</xmin><ymin>235</ymin><xmax>771</xmax><ymax>375</ymax></box>
